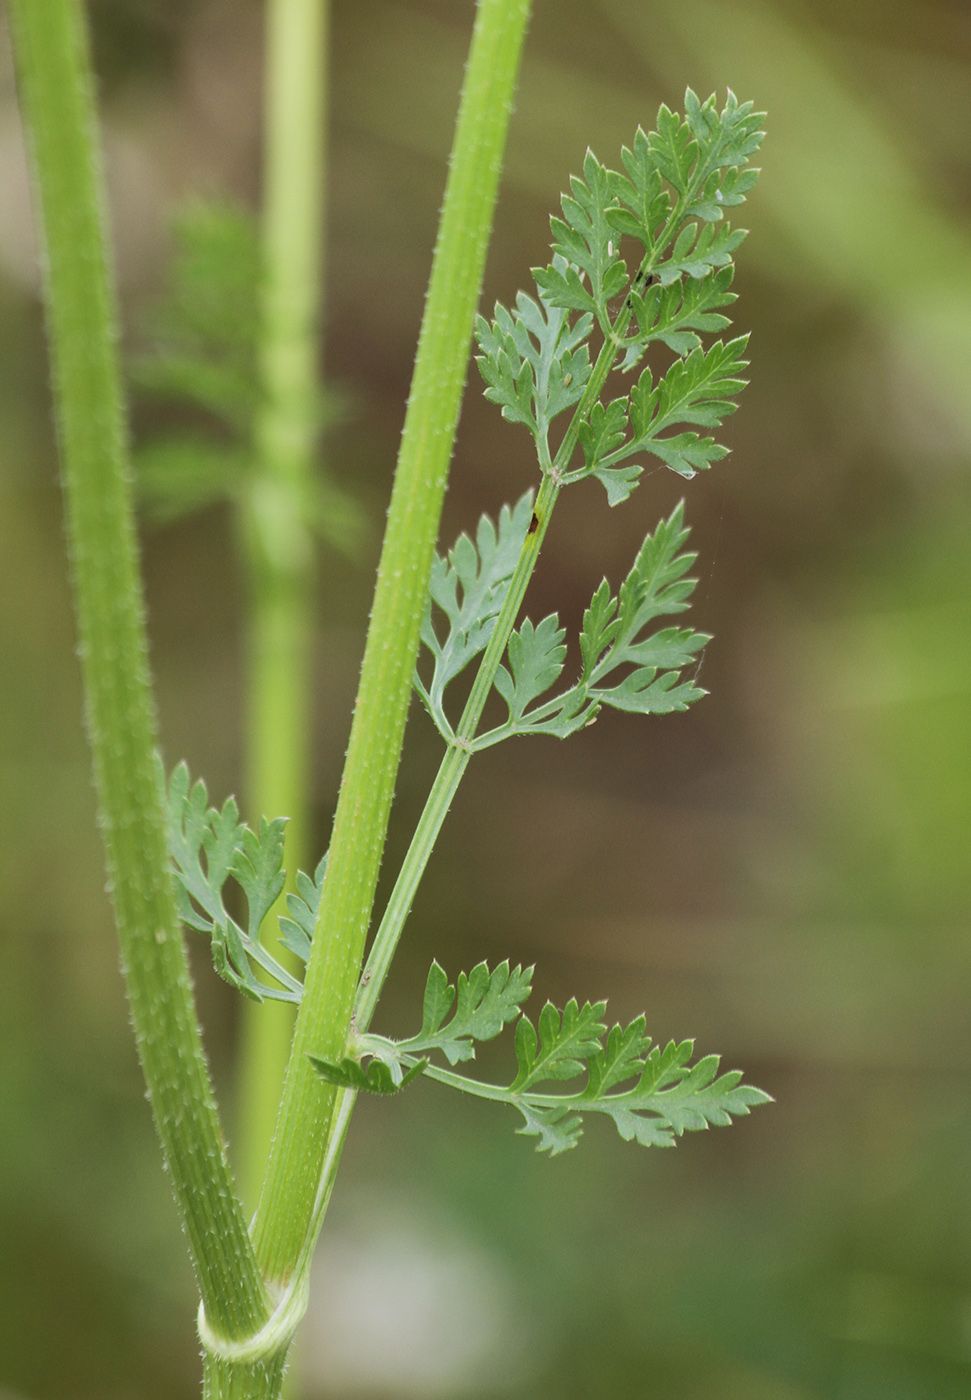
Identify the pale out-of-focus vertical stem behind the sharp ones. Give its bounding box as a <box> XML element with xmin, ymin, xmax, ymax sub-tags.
<box><xmin>238</xmin><ymin>0</ymin><xmax>330</xmax><ymax>1207</ymax></box>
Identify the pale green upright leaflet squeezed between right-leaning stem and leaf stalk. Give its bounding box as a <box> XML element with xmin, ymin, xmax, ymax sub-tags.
<box><xmin>414</xmin><ymin>491</ymin><xmax>533</xmax><ymax>739</ymax></box>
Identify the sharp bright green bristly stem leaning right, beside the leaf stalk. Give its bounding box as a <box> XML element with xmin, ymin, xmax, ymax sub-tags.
<box><xmin>255</xmin><ymin>0</ymin><xmax>529</xmax><ymax>1281</ymax></box>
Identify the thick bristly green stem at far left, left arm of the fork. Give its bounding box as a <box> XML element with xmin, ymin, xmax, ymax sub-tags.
<box><xmin>8</xmin><ymin>0</ymin><xmax>269</xmax><ymax>1338</ymax></box>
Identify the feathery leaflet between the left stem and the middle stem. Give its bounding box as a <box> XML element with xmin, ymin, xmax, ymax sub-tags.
<box><xmin>168</xmin><ymin>763</ymin><xmax>312</xmax><ymax>1002</ymax></box>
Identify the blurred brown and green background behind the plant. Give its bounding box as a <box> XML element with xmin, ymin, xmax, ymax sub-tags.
<box><xmin>0</xmin><ymin>0</ymin><xmax>971</xmax><ymax>1400</ymax></box>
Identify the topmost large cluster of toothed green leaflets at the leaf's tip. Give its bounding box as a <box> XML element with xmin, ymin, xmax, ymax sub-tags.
<box><xmin>477</xmin><ymin>100</ymin><xmax>764</xmax><ymax>505</ymax></box>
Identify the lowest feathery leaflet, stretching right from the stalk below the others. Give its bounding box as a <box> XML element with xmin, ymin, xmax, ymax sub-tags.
<box><xmin>331</xmin><ymin>962</ymin><xmax>771</xmax><ymax>1156</ymax></box>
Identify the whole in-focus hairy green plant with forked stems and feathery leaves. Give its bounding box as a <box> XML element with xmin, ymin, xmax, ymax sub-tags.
<box><xmin>10</xmin><ymin>0</ymin><xmax>765</xmax><ymax>1400</ymax></box>
